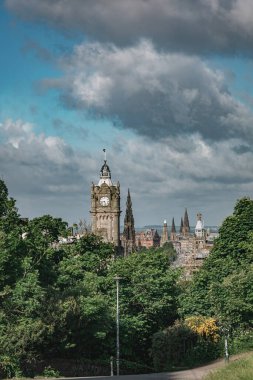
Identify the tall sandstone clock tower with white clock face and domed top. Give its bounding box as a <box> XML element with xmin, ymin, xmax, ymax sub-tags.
<box><xmin>90</xmin><ymin>150</ymin><xmax>121</xmax><ymax>247</ymax></box>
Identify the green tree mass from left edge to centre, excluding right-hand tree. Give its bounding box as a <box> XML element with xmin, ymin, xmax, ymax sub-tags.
<box><xmin>0</xmin><ymin>182</ymin><xmax>179</xmax><ymax>374</ymax></box>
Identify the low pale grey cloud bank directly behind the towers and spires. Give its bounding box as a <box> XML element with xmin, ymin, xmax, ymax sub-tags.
<box><xmin>0</xmin><ymin>120</ymin><xmax>253</xmax><ymax>225</ymax></box>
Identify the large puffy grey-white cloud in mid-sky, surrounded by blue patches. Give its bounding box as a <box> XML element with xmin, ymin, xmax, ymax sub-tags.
<box><xmin>41</xmin><ymin>41</ymin><xmax>253</xmax><ymax>141</ymax></box>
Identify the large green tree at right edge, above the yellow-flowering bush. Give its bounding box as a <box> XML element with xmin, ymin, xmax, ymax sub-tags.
<box><xmin>180</xmin><ymin>198</ymin><xmax>253</xmax><ymax>328</ymax></box>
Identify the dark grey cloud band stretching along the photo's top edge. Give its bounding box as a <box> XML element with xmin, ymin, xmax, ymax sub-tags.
<box><xmin>5</xmin><ymin>0</ymin><xmax>253</xmax><ymax>55</ymax></box>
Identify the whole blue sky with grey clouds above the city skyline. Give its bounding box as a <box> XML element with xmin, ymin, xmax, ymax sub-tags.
<box><xmin>0</xmin><ymin>0</ymin><xmax>253</xmax><ymax>226</ymax></box>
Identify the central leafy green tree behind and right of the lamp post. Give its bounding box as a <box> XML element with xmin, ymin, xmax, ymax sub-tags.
<box><xmin>108</xmin><ymin>250</ymin><xmax>179</xmax><ymax>362</ymax></box>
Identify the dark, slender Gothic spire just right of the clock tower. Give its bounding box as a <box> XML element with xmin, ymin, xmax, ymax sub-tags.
<box><xmin>122</xmin><ymin>189</ymin><xmax>136</xmax><ymax>256</ymax></box>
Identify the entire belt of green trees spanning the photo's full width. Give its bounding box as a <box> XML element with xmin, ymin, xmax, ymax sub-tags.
<box><xmin>0</xmin><ymin>181</ymin><xmax>253</xmax><ymax>376</ymax></box>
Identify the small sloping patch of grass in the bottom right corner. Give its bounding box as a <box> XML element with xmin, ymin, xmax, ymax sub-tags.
<box><xmin>205</xmin><ymin>355</ymin><xmax>253</xmax><ymax>380</ymax></box>
